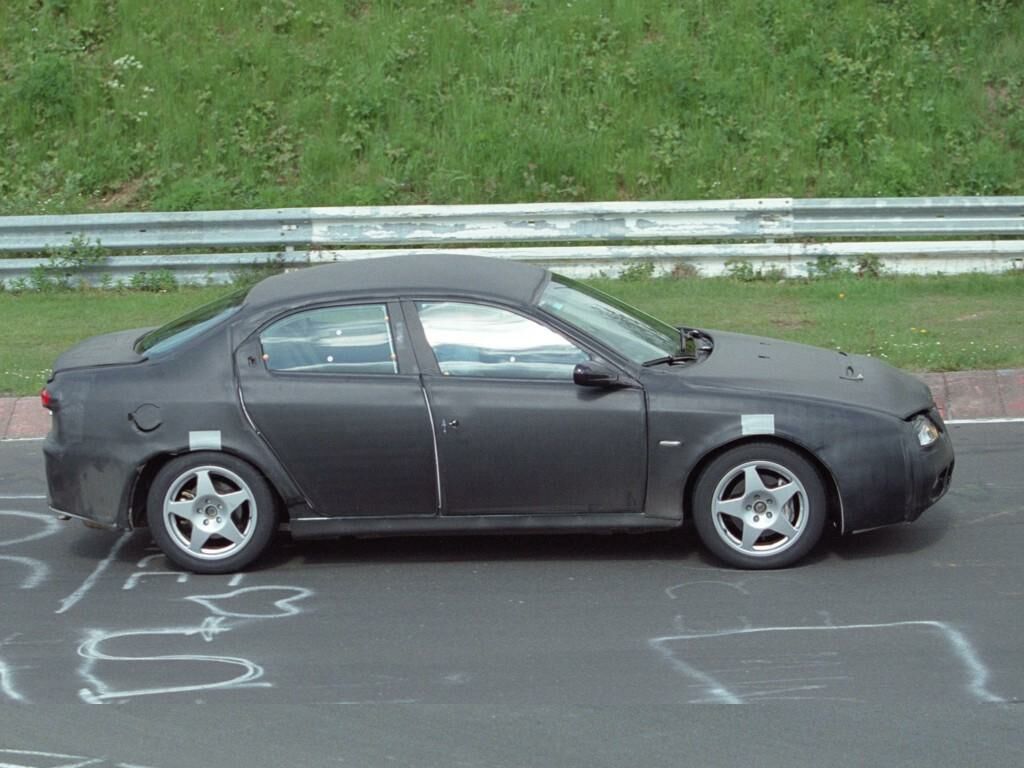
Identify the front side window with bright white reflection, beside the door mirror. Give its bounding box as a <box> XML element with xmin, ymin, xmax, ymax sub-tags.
<box><xmin>416</xmin><ymin>301</ymin><xmax>590</xmax><ymax>381</ymax></box>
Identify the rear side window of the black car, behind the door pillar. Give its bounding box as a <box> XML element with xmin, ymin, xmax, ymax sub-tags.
<box><xmin>259</xmin><ymin>304</ymin><xmax>398</xmax><ymax>374</ymax></box>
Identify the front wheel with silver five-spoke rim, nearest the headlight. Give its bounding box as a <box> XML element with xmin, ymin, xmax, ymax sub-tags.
<box><xmin>692</xmin><ymin>442</ymin><xmax>827</xmax><ymax>569</ymax></box>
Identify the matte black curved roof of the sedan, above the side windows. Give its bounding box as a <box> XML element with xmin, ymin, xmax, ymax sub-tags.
<box><xmin>246</xmin><ymin>253</ymin><xmax>549</xmax><ymax>307</ymax></box>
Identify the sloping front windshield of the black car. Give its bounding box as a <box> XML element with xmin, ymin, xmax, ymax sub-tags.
<box><xmin>540</xmin><ymin>274</ymin><xmax>681</xmax><ymax>364</ymax></box>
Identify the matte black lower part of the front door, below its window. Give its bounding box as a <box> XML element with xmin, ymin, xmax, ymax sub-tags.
<box><xmin>424</xmin><ymin>376</ymin><xmax>646</xmax><ymax>515</ymax></box>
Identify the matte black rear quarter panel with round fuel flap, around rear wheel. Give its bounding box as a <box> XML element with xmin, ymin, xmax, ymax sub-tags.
<box><xmin>43</xmin><ymin>319</ymin><xmax>302</xmax><ymax>528</ymax></box>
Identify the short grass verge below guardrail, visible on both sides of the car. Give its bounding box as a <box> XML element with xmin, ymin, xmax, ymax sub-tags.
<box><xmin>0</xmin><ymin>271</ymin><xmax>1024</xmax><ymax>394</ymax></box>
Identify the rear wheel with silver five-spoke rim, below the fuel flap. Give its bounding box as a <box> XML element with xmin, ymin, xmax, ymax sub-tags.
<box><xmin>146</xmin><ymin>452</ymin><xmax>278</xmax><ymax>573</ymax></box>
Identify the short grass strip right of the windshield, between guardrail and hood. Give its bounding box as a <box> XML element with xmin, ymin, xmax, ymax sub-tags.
<box><xmin>594</xmin><ymin>271</ymin><xmax>1024</xmax><ymax>371</ymax></box>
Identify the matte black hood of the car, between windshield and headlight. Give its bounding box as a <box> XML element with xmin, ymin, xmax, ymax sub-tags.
<box><xmin>675</xmin><ymin>331</ymin><xmax>932</xmax><ymax>419</ymax></box>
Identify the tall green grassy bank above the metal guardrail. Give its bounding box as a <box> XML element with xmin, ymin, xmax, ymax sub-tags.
<box><xmin>0</xmin><ymin>0</ymin><xmax>1024</xmax><ymax>214</ymax></box>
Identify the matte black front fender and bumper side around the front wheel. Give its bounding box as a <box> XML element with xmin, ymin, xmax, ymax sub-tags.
<box><xmin>642</xmin><ymin>356</ymin><xmax>952</xmax><ymax>532</ymax></box>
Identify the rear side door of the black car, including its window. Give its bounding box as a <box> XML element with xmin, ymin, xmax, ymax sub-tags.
<box><xmin>237</xmin><ymin>302</ymin><xmax>438</xmax><ymax>516</ymax></box>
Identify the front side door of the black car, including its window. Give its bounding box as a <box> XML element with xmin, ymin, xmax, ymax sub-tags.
<box><xmin>406</xmin><ymin>301</ymin><xmax>647</xmax><ymax>515</ymax></box>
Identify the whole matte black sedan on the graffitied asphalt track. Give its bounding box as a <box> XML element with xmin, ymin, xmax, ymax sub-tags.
<box><xmin>42</xmin><ymin>255</ymin><xmax>953</xmax><ymax>572</ymax></box>
